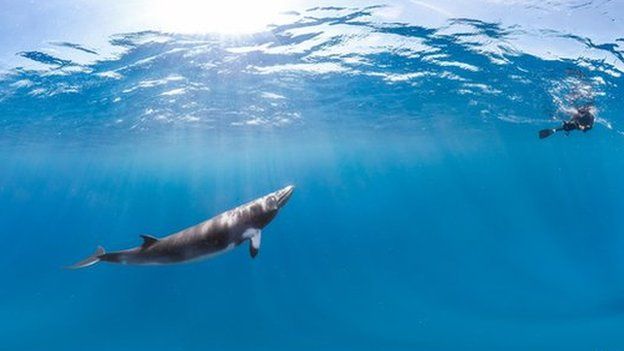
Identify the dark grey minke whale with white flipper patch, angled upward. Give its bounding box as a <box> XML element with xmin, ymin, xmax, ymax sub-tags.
<box><xmin>68</xmin><ymin>185</ymin><xmax>295</xmax><ymax>269</ymax></box>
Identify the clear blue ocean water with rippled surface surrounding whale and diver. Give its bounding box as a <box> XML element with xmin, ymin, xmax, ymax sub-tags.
<box><xmin>0</xmin><ymin>1</ymin><xmax>624</xmax><ymax>351</ymax></box>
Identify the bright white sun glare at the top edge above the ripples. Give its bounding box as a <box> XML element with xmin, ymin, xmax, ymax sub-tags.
<box><xmin>145</xmin><ymin>0</ymin><xmax>287</xmax><ymax>34</ymax></box>
